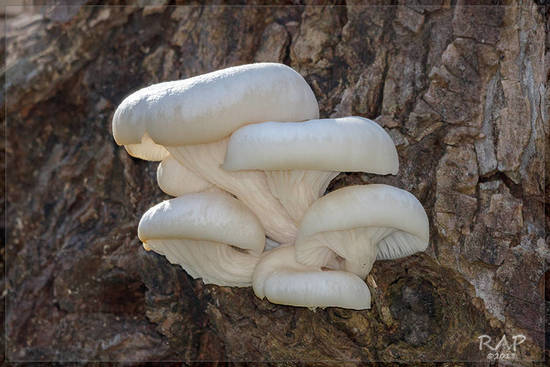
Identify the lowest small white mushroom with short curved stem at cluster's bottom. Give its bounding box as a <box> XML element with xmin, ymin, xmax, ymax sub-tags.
<box><xmin>252</xmin><ymin>246</ymin><xmax>371</xmax><ymax>310</ymax></box>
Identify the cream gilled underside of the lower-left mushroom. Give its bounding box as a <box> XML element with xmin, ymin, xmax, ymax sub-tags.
<box><xmin>144</xmin><ymin>239</ymin><xmax>259</xmax><ymax>287</ymax></box>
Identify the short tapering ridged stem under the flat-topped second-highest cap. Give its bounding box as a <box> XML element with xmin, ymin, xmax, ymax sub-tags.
<box><xmin>266</xmin><ymin>170</ymin><xmax>339</xmax><ymax>223</ymax></box>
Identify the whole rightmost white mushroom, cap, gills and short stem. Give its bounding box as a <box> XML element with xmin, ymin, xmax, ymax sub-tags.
<box><xmin>296</xmin><ymin>184</ymin><xmax>429</xmax><ymax>278</ymax></box>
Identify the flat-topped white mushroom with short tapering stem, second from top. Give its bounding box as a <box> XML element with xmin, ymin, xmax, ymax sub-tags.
<box><xmin>223</xmin><ymin>117</ymin><xmax>399</xmax><ymax>223</ymax></box>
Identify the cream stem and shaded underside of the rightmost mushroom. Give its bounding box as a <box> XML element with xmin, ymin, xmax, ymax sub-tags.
<box><xmin>296</xmin><ymin>227</ymin><xmax>395</xmax><ymax>279</ymax></box>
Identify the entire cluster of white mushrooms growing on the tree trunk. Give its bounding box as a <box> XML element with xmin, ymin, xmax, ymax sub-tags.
<box><xmin>113</xmin><ymin>63</ymin><xmax>429</xmax><ymax>309</ymax></box>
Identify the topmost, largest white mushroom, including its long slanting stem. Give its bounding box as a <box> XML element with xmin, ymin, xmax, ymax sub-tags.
<box><xmin>113</xmin><ymin>63</ymin><xmax>319</xmax><ymax>242</ymax></box>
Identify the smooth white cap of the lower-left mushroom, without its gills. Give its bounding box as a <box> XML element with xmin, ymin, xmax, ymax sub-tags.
<box><xmin>138</xmin><ymin>192</ymin><xmax>265</xmax><ymax>255</ymax></box>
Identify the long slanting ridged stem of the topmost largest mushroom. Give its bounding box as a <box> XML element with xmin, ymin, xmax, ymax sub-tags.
<box><xmin>166</xmin><ymin>138</ymin><xmax>297</xmax><ymax>243</ymax></box>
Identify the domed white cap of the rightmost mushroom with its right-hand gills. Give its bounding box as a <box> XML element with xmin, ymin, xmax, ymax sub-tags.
<box><xmin>296</xmin><ymin>184</ymin><xmax>429</xmax><ymax>264</ymax></box>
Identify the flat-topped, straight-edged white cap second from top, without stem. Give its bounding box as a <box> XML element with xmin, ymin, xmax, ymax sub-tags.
<box><xmin>223</xmin><ymin>116</ymin><xmax>399</xmax><ymax>174</ymax></box>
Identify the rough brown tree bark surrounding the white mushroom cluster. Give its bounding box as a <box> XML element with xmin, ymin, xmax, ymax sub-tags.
<box><xmin>2</xmin><ymin>0</ymin><xmax>550</xmax><ymax>363</ymax></box>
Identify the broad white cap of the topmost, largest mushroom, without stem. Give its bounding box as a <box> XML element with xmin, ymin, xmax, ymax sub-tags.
<box><xmin>113</xmin><ymin>63</ymin><xmax>319</xmax><ymax>146</ymax></box>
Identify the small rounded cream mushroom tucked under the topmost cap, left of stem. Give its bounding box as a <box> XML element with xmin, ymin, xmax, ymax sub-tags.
<box><xmin>157</xmin><ymin>155</ymin><xmax>213</xmax><ymax>196</ymax></box>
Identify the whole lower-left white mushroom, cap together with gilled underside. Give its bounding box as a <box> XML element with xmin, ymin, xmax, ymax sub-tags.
<box><xmin>138</xmin><ymin>192</ymin><xmax>265</xmax><ymax>287</ymax></box>
